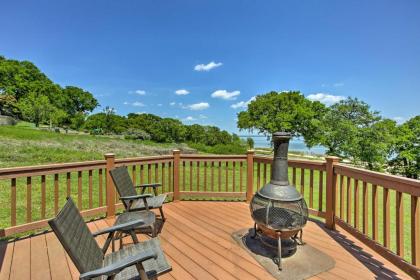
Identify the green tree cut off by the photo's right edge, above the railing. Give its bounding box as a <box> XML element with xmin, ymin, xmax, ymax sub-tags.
<box><xmin>389</xmin><ymin>115</ymin><xmax>420</xmax><ymax>179</ymax></box>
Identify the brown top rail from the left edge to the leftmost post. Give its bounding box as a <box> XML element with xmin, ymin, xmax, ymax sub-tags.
<box><xmin>0</xmin><ymin>160</ymin><xmax>106</xmax><ymax>179</ymax></box>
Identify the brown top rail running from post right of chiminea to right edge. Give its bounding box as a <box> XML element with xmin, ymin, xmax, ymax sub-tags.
<box><xmin>334</xmin><ymin>163</ymin><xmax>420</xmax><ymax>196</ymax></box>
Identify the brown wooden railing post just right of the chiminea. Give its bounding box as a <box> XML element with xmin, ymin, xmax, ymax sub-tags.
<box><xmin>325</xmin><ymin>156</ymin><xmax>340</xmax><ymax>229</ymax></box>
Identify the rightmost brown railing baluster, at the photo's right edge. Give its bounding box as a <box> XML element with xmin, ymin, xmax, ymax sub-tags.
<box><xmin>411</xmin><ymin>195</ymin><xmax>420</xmax><ymax>267</ymax></box>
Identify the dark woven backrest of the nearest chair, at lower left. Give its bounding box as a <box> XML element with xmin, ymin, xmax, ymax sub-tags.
<box><xmin>48</xmin><ymin>198</ymin><xmax>104</xmax><ymax>273</ymax></box>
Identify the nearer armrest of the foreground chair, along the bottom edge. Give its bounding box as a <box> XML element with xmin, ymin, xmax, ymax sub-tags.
<box><xmin>79</xmin><ymin>251</ymin><xmax>157</xmax><ymax>280</ymax></box>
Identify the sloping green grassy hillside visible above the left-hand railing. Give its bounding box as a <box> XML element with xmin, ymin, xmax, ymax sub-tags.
<box><xmin>0</xmin><ymin>125</ymin><xmax>195</xmax><ymax>168</ymax></box>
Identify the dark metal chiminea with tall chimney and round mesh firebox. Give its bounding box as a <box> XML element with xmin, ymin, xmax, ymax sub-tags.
<box><xmin>250</xmin><ymin>132</ymin><xmax>308</xmax><ymax>270</ymax></box>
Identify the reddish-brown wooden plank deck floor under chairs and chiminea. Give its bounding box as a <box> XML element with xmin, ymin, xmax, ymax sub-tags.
<box><xmin>0</xmin><ymin>201</ymin><xmax>410</xmax><ymax>280</ymax></box>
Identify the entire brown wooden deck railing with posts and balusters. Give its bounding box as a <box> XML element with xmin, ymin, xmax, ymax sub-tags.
<box><xmin>0</xmin><ymin>150</ymin><xmax>420</xmax><ymax>277</ymax></box>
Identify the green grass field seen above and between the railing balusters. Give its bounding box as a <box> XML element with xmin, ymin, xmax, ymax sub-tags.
<box><xmin>0</xmin><ymin>124</ymin><xmax>411</xmax><ymax>261</ymax></box>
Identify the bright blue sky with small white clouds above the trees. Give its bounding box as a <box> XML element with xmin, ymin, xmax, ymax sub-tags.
<box><xmin>0</xmin><ymin>0</ymin><xmax>420</xmax><ymax>131</ymax></box>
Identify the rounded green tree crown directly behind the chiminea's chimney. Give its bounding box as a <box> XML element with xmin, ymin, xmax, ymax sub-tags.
<box><xmin>238</xmin><ymin>91</ymin><xmax>326</xmax><ymax>146</ymax></box>
